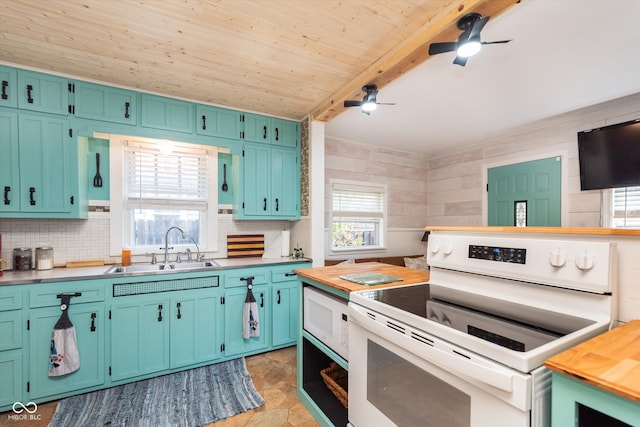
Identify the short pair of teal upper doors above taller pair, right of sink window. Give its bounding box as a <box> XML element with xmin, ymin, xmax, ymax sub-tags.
<box><xmin>244</xmin><ymin>113</ymin><xmax>300</xmax><ymax>147</ymax></box>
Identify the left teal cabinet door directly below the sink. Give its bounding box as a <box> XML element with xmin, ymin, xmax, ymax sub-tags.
<box><xmin>111</xmin><ymin>298</ymin><xmax>170</xmax><ymax>381</ymax></box>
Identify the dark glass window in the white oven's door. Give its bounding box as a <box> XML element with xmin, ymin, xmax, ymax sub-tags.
<box><xmin>367</xmin><ymin>340</ymin><xmax>471</xmax><ymax>427</ymax></box>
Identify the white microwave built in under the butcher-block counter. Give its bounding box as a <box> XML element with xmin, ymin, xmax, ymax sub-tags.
<box><xmin>303</xmin><ymin>286</ymin><xmax>349</xmax><ymax>360</ymax></box>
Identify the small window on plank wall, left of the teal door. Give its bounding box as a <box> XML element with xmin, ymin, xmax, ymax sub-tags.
<box><xmin>331</xmin><ymin>182</ymin><xmax>387</xmax><ymax>251</ymax></box>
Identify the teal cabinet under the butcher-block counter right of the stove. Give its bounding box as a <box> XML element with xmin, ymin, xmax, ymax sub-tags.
<box><xmin>551</xmin><ymin>372</ymin><xmax>640</xmax><ymax>427</ymax></box>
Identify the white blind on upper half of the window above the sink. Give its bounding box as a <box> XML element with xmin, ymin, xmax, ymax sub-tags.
<box><xmin>124</xmin><ymin>141</ymin><xmax>208</xmax><ymax>207</ymax></box>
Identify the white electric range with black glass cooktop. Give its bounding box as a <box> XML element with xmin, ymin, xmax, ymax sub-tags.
<box><xmin>349</xmin><ymin>231</ymin><xmax>616</xmax><ymax>427</ymax></box>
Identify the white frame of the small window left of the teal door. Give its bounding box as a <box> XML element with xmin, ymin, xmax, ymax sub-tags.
<box><xmin>328</xmin><ymin>179</ymin><xmax>389</xmax><ymax>254</ymax></box>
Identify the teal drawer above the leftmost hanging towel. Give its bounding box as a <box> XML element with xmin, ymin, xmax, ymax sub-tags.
<box><xmin>29</xmin><ymin>281</ymin><xmax>104</xmax><ymax>308</ymax></box>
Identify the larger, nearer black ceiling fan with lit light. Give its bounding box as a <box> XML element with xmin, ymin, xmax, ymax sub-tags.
<box><xmin>429</xmin><ymin>13</ymin><xmax>511</xmax><ymax>67</ymax></box>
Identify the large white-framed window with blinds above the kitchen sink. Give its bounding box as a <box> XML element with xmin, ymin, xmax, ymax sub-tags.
<box><xmin>110</xmin><ymin>137</ymin><xmax>218</xmax><ymax>254</ymax></box>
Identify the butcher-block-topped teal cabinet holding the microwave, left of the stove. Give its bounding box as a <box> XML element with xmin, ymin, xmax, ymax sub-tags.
<box><xmin>294</xmin><ymin>262</ymin><xmax>429</xmax><ymax>426</ymax></box>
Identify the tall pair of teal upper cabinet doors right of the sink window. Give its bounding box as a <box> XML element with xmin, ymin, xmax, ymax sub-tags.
<box><xmin>238</xmin><ymin>143</ymin><xmax>300</xmax><ymax>219</ymax></box>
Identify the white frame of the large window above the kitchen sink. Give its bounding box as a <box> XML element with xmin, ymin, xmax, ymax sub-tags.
<box><xmin>107</xmin><ymin>135</ymin><xmax>224</xmax><ymax>256</ymax></box>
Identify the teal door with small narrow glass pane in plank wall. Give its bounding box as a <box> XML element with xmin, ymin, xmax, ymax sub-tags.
<box><xmin>487</xmin><ymin>157</ymin><xmax>562</xmax><ymax>227</ymax></box>
